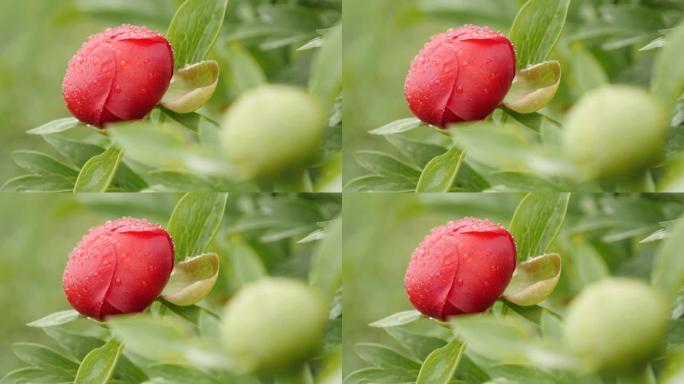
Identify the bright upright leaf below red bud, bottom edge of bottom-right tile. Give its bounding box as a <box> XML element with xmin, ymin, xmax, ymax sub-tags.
<box><xmin>416</xmin><ymin>339</ymin><xmax>465</xmax><ymax>384</ymax></box>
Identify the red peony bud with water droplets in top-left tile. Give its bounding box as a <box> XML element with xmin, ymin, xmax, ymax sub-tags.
<box><xmin>62</xmin><ymin>25</ymin><xmax>173</xmax><ymax>127</ymax></box>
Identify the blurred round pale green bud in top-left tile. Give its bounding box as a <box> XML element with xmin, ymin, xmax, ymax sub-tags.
<box><xmin>221</xmin><ymin>85</ymin><xmax>325</xmax><ymax>178</ymax></box>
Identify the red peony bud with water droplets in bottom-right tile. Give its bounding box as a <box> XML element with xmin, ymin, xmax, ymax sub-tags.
<box><xmin>404</xmin><ymin>218</ymin><xmax>515</xmax><ymax>320</ymax></box>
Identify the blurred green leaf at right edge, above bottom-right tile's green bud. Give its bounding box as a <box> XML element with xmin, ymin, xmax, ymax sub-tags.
<box><xmin>652</xmin><ymin>220</ymin><xmax>684</xmax><ymax>300</ymax></box>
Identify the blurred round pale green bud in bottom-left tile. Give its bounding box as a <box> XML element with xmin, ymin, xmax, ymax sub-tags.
<box><xmin>221</xmin><ymin>278</ymin><xmax>327</xmax><ymax>372</ymax></box>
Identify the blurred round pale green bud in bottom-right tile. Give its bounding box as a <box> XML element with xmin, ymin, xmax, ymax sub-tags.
<box><xmin>564</xmin><ymin>278</ymin><xmax>669</xmax><ymax>371</ymax></box>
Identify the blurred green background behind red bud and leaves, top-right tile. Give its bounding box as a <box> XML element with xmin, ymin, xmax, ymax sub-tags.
<box><xmin>343</xmin><ymin>0</ymin><xmax>684</xmax><ymax>183</ymax></box>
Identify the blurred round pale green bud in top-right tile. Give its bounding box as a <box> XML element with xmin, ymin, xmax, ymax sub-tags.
<box><xmin>563</xmin><ymin>85</ymin><xmax>668</xmax><ymax>180</ymax></box>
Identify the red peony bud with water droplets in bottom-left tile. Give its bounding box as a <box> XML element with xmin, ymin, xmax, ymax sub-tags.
<box><xmin>63</xmin><ymin>217</ymin><xmax>173</xmax><ymax>320</ymax></box>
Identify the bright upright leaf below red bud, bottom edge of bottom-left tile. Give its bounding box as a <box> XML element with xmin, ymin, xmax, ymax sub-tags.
<box><xmin>74</xmin><ymin>339</ymin><xmax>123</xmax><ymax>384</ymax></box>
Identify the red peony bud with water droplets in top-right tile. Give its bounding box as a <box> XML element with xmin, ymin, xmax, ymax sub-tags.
<box><xmin>404</xmin><ymin>25</ymin><xmax>515</xmax><ymax>127</ymax></box>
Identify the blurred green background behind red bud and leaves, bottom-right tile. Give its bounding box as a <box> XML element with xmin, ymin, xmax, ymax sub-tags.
<box><xmin>343</xmin><ymin>193</ymin><xmax>684</xmax><ymax>375</ymax></box>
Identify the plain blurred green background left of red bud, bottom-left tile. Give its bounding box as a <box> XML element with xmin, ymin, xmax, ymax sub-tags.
<box><xmin>0</xmin><ymin>193</ymin><xmax>176</xmax><ymax>376</ymax></box>
